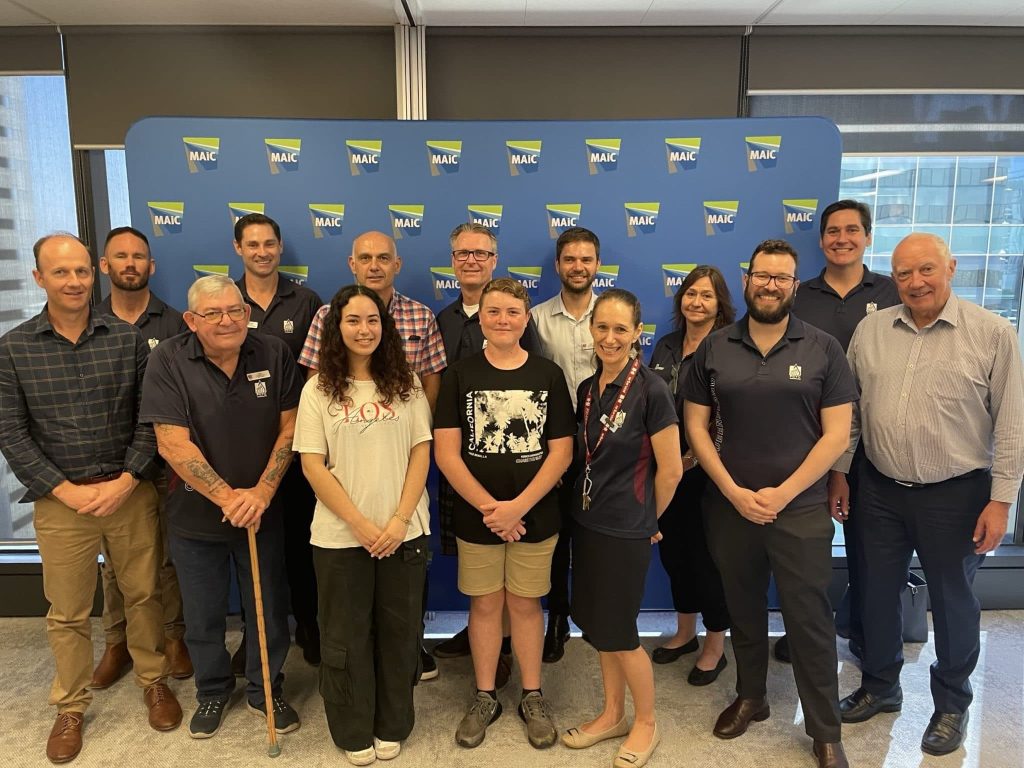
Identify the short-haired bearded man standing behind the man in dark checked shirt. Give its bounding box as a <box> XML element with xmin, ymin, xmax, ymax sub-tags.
<box><xmin>89</xmin><ymin>226</ymin><xmax>193</xmax><ymax>690</ymax></box>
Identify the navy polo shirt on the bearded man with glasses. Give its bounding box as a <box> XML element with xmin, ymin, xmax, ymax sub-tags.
<box><xmin>683</xmin><ymin>314</ymin><xmax>857</xmax><ymax>507</ymax></box>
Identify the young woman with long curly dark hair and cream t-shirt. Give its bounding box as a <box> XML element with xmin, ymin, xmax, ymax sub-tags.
<box><xmin>293</xmin><ymin>286</ymin><xmax>431</xmax><ymax>765</ymax></box>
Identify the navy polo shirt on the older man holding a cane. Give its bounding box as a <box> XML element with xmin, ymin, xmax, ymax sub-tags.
<box><xmin>139</xmin><ymin>333</ymin><xmax>303</xmax><ymax>541</ymax></box>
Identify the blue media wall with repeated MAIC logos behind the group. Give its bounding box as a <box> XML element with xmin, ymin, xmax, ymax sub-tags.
<box><xmin>126</xmin><ymin>118</ymin><xmax>842</xmax><ymax>609</ymax></box>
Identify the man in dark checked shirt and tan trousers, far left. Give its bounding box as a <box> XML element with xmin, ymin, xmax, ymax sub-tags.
<box><xmin>0</xmin><ymin>233</ymin><xmax>181</xmax><ymax>763</ymax></box>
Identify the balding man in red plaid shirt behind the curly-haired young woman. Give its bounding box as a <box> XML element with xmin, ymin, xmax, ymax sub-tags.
<box><xmin>299</xmin><ymin>231</ymin><xmax>447</xmax><ymax>410</ymax></box>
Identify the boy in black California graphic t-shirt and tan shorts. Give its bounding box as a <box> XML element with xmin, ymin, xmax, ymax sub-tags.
<box><xmin>434</xmin><ymin>278</ymin><xmax>575</xmax><ymax>749</ymax></box>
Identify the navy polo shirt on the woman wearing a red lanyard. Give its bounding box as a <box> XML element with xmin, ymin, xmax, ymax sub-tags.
<box><xmin>571</xmin><ymin>365</ymin><xmax>679</xmax><ymax>539</ymax></box>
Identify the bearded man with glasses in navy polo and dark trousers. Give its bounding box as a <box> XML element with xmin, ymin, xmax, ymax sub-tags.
<box><xmin>683</xmin><ymin>240</ymin><xmax>857</xmax><ymax>768</ymax></box>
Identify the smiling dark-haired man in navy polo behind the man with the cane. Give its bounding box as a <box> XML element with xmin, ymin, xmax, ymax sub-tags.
<box><xmin>234</xmin><ymin>213</ymin><xmax>323</xmax><ymax>673</ymax></box>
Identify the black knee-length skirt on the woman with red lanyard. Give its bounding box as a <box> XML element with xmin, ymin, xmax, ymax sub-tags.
<box><xmin>571</xmin><ymin>523</ymin><xmax>651</xmax><ymax>652</ymax></box>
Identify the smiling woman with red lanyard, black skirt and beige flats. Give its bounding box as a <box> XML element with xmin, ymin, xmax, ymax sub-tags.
<box><xmin>562</xmin><ymin>289</ymin><xmax>683</xmax><ymax>768</ymax></box>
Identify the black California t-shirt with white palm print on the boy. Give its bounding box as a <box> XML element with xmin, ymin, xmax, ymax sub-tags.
<box><xmin>434</xmin><ymin>352</ymin><xmax>575</xmax><ymax>544</ymax></box>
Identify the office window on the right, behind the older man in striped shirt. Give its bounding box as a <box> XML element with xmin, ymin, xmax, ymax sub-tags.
<box><xmin>751</xmin><ymin>93</ymin><xmax>1024</xmax><ymax>542</ymax></box>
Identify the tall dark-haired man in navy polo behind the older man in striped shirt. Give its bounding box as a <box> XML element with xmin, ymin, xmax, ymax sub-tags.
<box><xmin>775</xmin><ymin>200</ymin><xmax>899</xmax><ymax>662</ymax></box>
